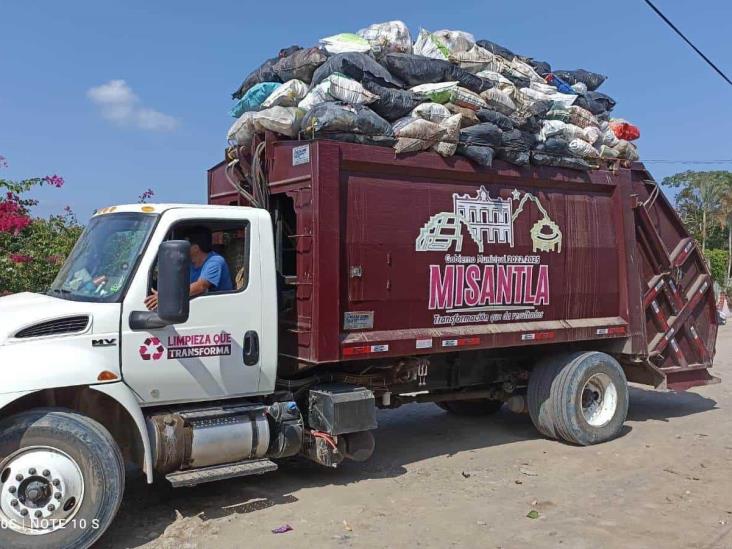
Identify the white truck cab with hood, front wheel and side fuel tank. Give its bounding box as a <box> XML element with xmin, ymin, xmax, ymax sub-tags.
<box><xmin>0</xmin><ymin>204</ymin><xmax>302</xmax><ymax>547</ymax></box>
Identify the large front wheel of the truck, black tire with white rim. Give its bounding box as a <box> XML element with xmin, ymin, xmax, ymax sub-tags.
<box><xmin>0</xmin><ymin>408</ymin><xmax>125</xmax><ymax>549</ymax></box>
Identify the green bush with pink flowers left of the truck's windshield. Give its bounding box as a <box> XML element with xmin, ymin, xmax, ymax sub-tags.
<box><xmin>0</xmin><ymin>156</ymin><xmax>81</xmax><ymax>296</ymax></box>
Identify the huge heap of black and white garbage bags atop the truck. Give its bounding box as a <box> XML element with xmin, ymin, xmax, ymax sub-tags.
<box><xmin>228</xmin><ymin>21</ymin><xmax>640</xmax><ymax>170</ymax></box>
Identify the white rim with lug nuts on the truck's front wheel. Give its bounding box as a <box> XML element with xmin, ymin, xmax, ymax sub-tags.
<box><xmin>0</xmin><ymin>446</ymin><xmax>84</xmax><ymax>535</ymax></box>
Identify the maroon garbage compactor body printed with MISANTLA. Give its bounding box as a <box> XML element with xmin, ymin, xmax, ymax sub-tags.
<box><xmin>208</xmin><ymin>139</ymin><xmax>717</xmax><ymax>390</ymax></box>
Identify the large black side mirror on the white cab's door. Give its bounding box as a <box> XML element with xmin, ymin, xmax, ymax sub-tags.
<box><xmin>158</xmin><ymin>240</ymin><xmax>191</xmax><ymax>324</ymax></box>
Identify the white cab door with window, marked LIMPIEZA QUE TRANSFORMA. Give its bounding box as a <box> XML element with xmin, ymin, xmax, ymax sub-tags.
<box><xmin>122</xmin><ymin>208</ymin><xmax>271</xmax><ymax>404</ymax></box>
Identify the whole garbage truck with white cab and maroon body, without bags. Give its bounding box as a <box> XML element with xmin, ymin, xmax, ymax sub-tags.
<box><xmin>0</xmin><ymin>134</ymin><xmax>719</xmax><ymax>548</ymax></box>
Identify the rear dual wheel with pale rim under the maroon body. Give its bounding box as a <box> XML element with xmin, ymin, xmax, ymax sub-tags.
<box><xmin>527</xmin><ymin>351</ymin><xmax>628</xmax><ymax>446</ymax></box>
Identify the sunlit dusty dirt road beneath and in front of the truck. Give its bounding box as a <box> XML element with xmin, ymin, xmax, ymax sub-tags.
<box><xmin>98</xmin><ymin>326</ymin><xmax>732</xmax><ymax>549</ymax></box>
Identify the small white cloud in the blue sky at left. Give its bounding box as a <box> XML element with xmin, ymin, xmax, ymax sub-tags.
<box><xmin>86</xmin><ymin>80</ymin><xmax>179</xmax><ymax>132</ymax></box>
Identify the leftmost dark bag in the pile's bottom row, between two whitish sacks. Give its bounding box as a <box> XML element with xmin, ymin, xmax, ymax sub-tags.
<box><xmin>300</xmin><ymin>102</ymin><xmax>394</xmax><ymax>138</ymax></box>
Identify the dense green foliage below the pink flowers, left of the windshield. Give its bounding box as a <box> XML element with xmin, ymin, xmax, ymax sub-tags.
<box><xmin>0</xmin><ymin>211</ymin><xmax>82</xmax><ymax>295</ymax></box>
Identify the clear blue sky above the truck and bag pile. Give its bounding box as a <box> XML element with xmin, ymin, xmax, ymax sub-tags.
<box><xmin>0</xmin><ymin>0</ymin><xmax>732</xmax><ymax>220</ymax></box>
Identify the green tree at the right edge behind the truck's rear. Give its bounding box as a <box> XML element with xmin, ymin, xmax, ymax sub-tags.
<box><xmin>663</xmin><ymin>171</ymin><xmax>732</xmax><ymax>251</ymax></box>
